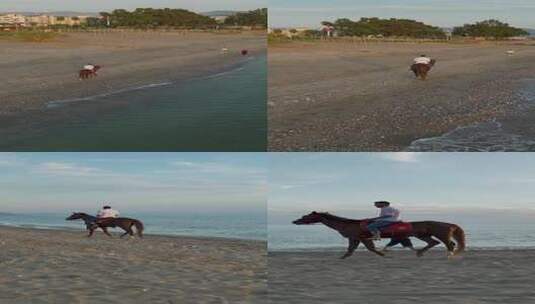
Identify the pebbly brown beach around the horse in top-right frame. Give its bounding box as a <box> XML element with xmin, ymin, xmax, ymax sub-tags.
<box><xmin>268</xmin><ymin>40</ymin><xmax>535</xmax><ymax>151</ymax></box>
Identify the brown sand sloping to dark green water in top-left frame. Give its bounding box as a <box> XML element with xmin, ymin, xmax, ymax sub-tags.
<box><xmin>0</xmin><ymin>31</ymin><xmax>266</xmax><ymax>119</ymax></box>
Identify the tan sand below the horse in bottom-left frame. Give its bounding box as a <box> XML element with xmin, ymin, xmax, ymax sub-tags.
<box><xmin>0</xmin><ymin>227</ymin><xmax>266</xmax><ymax>304</ymax></box>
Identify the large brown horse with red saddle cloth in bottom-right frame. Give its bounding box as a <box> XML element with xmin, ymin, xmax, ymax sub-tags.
<box><xmin>293</xmin><ymin>211</ymin><xmax>465</xmax><ymax>259</ymax></box>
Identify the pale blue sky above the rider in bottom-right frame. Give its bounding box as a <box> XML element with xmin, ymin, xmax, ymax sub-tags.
<box><xmin>268</xmin><ymin>153</ymin><xmax>535</xmax><ymax>218</ymax></box>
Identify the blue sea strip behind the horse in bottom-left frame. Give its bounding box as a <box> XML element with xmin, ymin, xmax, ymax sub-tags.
<box><xmin>0</xmin><ymin>213</ymin><xmax>266</xmax><ymax>240</ymax></box>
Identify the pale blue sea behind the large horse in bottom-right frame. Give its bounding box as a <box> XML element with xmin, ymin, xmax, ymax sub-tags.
<box><xmin>268</xmin><ymin>211</ymin><xmax>535</xmax><ymax>251</ymax></box>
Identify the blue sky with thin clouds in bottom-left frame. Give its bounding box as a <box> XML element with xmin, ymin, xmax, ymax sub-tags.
<box><xmin>0</xmin><ymin>153</ymin><xmax>267</xmax><ymax>214</ymax></box>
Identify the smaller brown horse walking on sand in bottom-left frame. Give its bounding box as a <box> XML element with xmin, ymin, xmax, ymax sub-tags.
<box><xmin>66</xmin><ymin>212</ymin><xmax>144</xmax><ymax>237</ymax></box>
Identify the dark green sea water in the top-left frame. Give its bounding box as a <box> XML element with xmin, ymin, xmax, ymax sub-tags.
<box><xmin>0</xmin><ymin>55</ymin><xmax>267</xmax><ymax>151</ymax></box>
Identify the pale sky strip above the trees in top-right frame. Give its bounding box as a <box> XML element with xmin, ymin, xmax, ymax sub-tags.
<box><xmin>269</xmin><ymin>0</ymin><xmax>535</xmax><ymax>28</ymax></box>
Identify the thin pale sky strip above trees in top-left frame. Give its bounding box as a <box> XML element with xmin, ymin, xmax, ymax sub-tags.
<box><xmin>0</xmin><ymin>0</ymin><xmax>267</xmax><ymax>12</ymax></box>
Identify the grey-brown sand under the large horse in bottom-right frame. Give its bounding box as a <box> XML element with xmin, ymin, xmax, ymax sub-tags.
<box><xmin>268</xmin><ymin>249</ymin><xmax>535</xmax><ymax>304</ymax></box>
